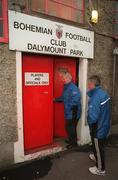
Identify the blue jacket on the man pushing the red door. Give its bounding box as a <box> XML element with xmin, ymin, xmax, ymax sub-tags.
<box><xmin>55</xmin><ymin>82</ymin><xmax>81</xmax><ymax>120</ymax></box>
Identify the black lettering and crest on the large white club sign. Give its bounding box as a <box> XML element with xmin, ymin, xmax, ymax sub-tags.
<box><xmin>14</xmin><ymin>21</ymin><xmax>91</xmax><ymax>56</ymax></box>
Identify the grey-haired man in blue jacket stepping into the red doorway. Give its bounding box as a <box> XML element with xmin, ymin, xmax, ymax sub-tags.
<box><xmin>55</xmin><ymin>68</ymin><xmax>81</xmax><ymax>148</ymax></box>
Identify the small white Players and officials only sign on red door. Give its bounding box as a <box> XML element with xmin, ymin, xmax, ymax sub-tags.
<box><xmin>25</xmin><ymin>72</ymin><xmax>49</xmax><ymax>86</ymax></box>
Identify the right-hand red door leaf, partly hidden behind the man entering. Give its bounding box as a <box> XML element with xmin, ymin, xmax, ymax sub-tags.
<box><xmin>54</xmin><ymin>57</ymin><xmax>76</xmax><ymax>137</ymax></box>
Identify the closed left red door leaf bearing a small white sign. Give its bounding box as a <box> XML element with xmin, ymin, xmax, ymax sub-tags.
<box><xmin>23</xmin><ymin>54</ymin><xmax>53</xmax><ymax>150</ymax></box>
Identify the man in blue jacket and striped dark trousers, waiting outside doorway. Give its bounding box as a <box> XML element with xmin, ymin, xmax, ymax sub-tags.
<box><xmin>87</xmin><ymin>76</ymin><xmax>111</xmax><ymax>175</ymax></box>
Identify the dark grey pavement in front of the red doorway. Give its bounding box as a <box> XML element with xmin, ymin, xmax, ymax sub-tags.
<box><xmin>0</xmin><ymin>138</ymin><xmax>118</xmax><ymax>180</ymax></box>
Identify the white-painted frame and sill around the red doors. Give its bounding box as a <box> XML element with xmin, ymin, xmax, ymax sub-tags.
<box><xmin>14</xmin><ymin>51</ymin><xmax>90</xmax><ymax>163</ymax></box>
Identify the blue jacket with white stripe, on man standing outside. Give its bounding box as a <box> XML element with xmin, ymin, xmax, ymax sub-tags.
<box><xmin>87</xmin><ymin>86</ymin><xmax>111</xmax><ymax>139</ymax></box>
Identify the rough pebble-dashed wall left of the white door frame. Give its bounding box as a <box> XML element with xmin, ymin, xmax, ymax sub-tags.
<box><xmin>0</xmin><ymin>1</ymin><xmax>25</xmax><ymax>168</ymax></box>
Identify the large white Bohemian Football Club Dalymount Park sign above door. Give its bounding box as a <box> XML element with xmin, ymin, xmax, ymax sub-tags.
<box><xmin>9</xmin><ymin>11</ymin><xmax>94</xmax><ymax>58</ymax></box>
